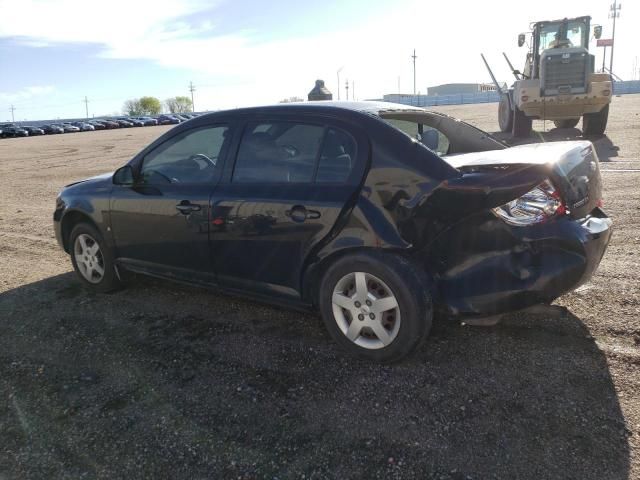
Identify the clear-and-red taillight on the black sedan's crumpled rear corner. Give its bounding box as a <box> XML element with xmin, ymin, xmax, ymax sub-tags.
<box><xmin>492</xmin><ymin>180</ymin><xmax>568</xmax><ymax>227</ymax></box>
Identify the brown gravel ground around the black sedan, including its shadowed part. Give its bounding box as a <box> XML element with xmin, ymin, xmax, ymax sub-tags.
<box><xmin>0</xmin><ymin>95</ymin><xmax>640</xmax><ymax>480</ymax></box>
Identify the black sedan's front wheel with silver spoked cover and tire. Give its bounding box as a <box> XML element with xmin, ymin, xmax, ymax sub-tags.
<box><xmin>69</xmin><ymin>223</ymin><xmax>121</xmax><ymax>293</ymax></box>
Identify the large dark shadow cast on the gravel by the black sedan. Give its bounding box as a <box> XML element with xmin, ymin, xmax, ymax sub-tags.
<box><xmin>0</xmin><ymin>274</ymin><xmax>629</xmax><ymax>479</ymax></box>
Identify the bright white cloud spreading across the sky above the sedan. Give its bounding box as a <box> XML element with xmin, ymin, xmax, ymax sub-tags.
<box><xmin>0</xmin><ymin>0</ymin><xmax>637</xmax><ymax>112</ymax></box>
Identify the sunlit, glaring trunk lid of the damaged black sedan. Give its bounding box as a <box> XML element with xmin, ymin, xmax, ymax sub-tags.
<box><xmin>443</xmin><ymin>141</ymin><xmax>602</xmax><ymax>218</ymax></box>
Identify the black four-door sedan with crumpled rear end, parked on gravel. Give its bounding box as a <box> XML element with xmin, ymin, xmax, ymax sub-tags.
<box><xmin>54</xmin><ymin>102</ymin><xmax>611</xmax><ymax>361</ymax></box>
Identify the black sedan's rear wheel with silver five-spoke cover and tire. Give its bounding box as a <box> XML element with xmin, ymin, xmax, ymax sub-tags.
<box><xmin>319</xmin><ymin>253</ymin><xmax>433</xmax><ymax>363</ymax></box>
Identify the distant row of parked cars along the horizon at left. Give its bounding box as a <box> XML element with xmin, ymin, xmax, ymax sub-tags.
<box><xmin>0</xmin><ymin>113</ymin><xmax>200</xmax><ymax>138</ymax></box>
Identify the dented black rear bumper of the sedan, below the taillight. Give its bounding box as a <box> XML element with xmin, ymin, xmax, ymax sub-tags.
<box><xmin>428</xmin><ymin>208</ymin><xmax>611</xmax><ymax>316</ymax></box>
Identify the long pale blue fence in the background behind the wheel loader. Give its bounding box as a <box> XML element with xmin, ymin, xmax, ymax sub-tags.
<box><xmin>384</xmin><ymin>80</ymin><xmax>640</xmax><ymax>107</ymax></box>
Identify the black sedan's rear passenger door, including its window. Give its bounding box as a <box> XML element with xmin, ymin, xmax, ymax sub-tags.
<box><xmin>211</xmin><ymin>119</ymin><xmax>368</xmax><ymax>297</ymax></box>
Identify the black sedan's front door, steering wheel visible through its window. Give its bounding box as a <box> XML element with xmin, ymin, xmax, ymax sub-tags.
<box><xmin>111</xmin><ymin>124</ymin><xmax>231</xmax><ymax>280</ymax></box>
